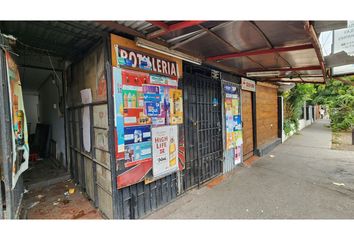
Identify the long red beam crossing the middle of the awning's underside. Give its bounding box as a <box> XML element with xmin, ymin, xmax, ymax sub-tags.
<box><xmin>207</xmin><ymin>44</ymin><xmax>313</xmax><ymax>61</ymax></box>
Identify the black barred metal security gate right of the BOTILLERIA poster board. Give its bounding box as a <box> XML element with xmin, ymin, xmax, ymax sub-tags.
<box><xmin>183</xmin><ymin>66</ymin><xmax>222</xmax><ymax>190</ymax></box>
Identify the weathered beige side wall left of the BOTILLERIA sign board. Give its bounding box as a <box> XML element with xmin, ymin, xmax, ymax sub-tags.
<box><xmin>67</xmin><ymin>44</ymin><xmax>113</xmax><ymax>218</ymax></box>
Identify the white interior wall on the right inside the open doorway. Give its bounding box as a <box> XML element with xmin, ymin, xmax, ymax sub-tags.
<box><xmin>39</xmin><ymin>74</ymin><xmax>65</xmax><ymax>166</ymax></box>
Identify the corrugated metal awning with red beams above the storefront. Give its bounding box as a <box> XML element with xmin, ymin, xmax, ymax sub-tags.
<box><xmin>0</xmin><ymin>21</ymin><xmax>327</xmax><ymax>83</ymax></box>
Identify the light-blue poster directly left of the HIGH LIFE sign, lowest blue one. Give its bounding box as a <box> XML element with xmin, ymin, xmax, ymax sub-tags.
<box><xmin>124</xmin><ymin>141</ymin><xmax>152</xmax><ymax>162</ymax></box>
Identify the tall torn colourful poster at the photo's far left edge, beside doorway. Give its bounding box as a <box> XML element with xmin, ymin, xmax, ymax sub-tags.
<box><xmin>5</xmin><ymin>52</ymin><xmax>29</xmax><ymax>189</ymax></box>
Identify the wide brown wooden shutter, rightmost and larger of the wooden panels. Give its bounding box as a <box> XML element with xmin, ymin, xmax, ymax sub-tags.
<box><xmin>256</xmin><ymin>83</ymin><xmax>278</xmax><ymax>147</ymax></box>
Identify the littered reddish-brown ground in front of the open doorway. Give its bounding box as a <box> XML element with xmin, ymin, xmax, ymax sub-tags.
<box><xmin>20</xmin><ymin>179</ymin><xmax>103</xmax><ymax>219</ymax></box>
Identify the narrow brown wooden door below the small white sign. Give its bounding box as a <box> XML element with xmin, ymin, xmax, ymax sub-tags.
<box><xmin>242</xmin><ymin>90</ymin><xmax>253</xmax><ymax>160</ymax></box>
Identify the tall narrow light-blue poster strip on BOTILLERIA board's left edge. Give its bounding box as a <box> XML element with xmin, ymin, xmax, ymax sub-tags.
<box><xmin>113</xmin><ymin>67</ymin><xmax>124</xmax><ymax>159</ymax></box>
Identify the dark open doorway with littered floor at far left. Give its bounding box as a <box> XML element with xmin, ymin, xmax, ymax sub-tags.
<box><xmin>17</xmin><ymin>63</ymin><xmax>70</xmax><ymax>190</ymax></box>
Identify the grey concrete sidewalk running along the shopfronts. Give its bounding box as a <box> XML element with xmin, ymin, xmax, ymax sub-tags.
<box><xmin>147</xmin><ymin>120</ymin><xmax>354</xmax><ymax>219</ymax></box>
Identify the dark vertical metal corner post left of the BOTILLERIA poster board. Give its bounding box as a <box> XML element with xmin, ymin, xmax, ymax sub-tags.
<box><xmin>104</xmin><ymin>35</ymin><xmax>119</xmax><ymax>219</ymax></box>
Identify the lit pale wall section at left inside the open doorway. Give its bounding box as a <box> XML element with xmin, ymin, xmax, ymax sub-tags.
<box><xmin>23</xmin><ymin>92</ymin><xmax>39</xmax><ymax>134</ymax></box>
